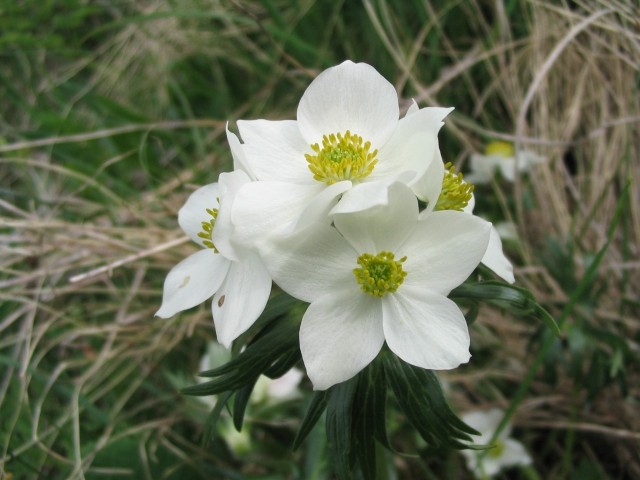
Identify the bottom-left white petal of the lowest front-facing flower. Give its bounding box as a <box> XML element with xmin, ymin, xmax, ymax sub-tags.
<box><xmin>300</xmin><ymin>291</ymin><xmax>384</xmax><ymax>390</ymax></box>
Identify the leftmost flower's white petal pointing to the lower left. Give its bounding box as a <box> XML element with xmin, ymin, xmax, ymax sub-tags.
<box><xmin>156</xmin><ymin>249</ymin><xmax>229</xmax><ymax>318</ymax></box>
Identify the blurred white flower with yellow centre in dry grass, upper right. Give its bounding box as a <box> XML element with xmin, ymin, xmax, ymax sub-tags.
<box><xmin>467</xmin><ymin>141</ymin><xmax>545</xmax><ymax>184</ymax></box>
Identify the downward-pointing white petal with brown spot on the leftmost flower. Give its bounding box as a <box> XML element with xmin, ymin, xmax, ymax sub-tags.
<box><xmin>211</xmin><ymin>253</ymin><xmax>271</xmax><ymax>347</ymax></box>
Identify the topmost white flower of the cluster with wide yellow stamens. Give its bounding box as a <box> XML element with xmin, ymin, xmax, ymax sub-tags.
<box><xmin>232</xmin><ymin>61</ymin><xmax>452</xmax><ymax>251</ymax></box>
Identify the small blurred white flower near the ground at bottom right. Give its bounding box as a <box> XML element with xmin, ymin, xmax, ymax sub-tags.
<box><xmin>461</xmin><ymin>408</ymin><xmax>532</xmax><ymax>479</ymax></box>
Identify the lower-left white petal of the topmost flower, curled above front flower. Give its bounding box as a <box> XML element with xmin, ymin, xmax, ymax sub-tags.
<box><xmin>231</xmin><ymin>182</ymin><xmax>325</xmax><ymax>249</ymax></box>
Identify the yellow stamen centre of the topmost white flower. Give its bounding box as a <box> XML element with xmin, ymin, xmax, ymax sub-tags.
<box><xmin>305</xmin><ymin>130</ymin><xmax>378</xmax><ymax>185</ymax></box>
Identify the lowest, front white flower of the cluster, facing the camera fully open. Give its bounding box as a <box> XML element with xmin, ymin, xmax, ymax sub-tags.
<box><xmin>265</xmin><ymin>183</ymin><xmax>491</xmax><ymax>390</ymax></box>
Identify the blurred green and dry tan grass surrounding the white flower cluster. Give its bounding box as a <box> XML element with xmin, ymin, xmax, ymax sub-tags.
<box><xmin>0</xmin><ymin>0</ymin><xmax>640</xmax><ymax>480</ymax></box>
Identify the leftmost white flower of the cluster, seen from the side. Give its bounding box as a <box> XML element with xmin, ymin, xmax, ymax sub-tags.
<box><xmin>156</xmin><ymin>170</ymin><xmax>271</xmax><ymax>347</ymax></box>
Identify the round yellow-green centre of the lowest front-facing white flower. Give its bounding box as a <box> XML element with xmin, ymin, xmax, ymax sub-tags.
<box><xmin>353</xmin><ymin>251</ymin><xmax>407</xmax><ymax>297</ymax></box>
